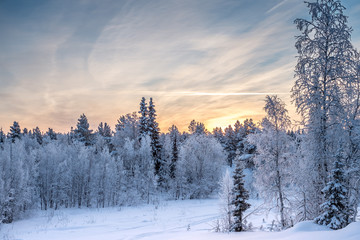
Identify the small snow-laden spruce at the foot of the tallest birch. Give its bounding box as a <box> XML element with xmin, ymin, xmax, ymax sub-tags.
<box><xmin>315</xmin><ymin>152</ymin><xmax>351</xmax><ymax>230</ymax></box>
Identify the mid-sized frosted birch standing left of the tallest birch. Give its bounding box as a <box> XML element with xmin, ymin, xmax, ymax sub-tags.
<box><xmin>249</xmin><ymin>96</ymin><xmax>293</xmax><ymax>228</ymax></box>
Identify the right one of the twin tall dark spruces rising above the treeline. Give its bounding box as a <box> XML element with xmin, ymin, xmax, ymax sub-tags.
<box><xmin>148</xmin><ymin>98</ymin><xmax>163</xmax><ymax>181</ymax></box>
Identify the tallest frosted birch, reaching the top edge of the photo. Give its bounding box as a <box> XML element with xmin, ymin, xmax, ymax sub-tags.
<box><xmin>292</xmin><ymin>0</ymin><xmax>354</xmax><ymax>215</ymax></box>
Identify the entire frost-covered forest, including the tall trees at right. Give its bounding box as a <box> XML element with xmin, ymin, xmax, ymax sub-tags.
<box><xmin>0</xmin><ymin>0</ymin><xmax>360</xmax><ymax>231</ymax></box>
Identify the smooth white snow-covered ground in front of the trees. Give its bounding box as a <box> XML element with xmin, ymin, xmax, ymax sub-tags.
<box><xmin>0</xmin><ymin>199</ymin><xmax>360</xmax><ymax>240</ymax></box>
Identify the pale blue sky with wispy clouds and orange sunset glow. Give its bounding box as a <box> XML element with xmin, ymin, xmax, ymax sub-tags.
<box><xmin>0</xmin><ymin>0</ymin><xmax>360</xmax><ymax>132</ymax></box>
